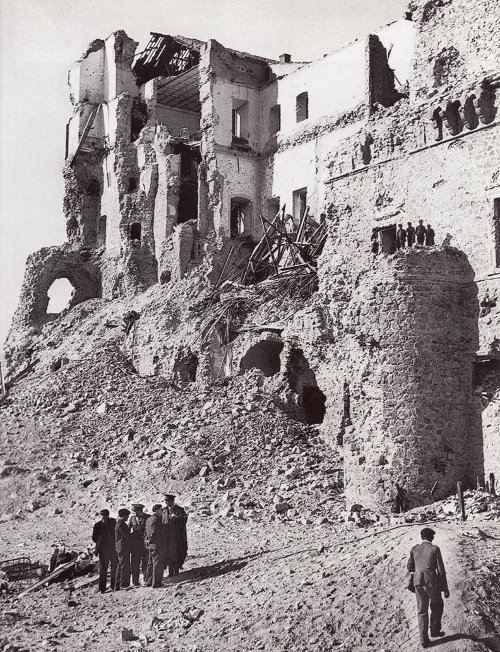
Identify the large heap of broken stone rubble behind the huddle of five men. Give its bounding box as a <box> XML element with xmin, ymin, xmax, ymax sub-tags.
<box><xmin>0</xmin><ymin>342</ymin><xmax>342</xmax><ymax>524</ymax></box>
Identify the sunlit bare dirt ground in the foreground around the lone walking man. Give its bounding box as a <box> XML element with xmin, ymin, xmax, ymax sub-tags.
<box><xmin>5</xmin><ymin>518</ymin><xmax>500</xmax><ymax>652</ymax></box>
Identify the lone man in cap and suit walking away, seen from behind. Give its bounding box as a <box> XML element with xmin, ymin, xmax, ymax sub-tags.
<box><xmin>407</xmin><ymin>527</ymin><xmax>450</xmax><ymax>648</ymax></box>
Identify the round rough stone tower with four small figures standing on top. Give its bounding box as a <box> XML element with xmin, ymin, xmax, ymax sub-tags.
<box><xmin>342</xmin><ymin>249</ymin><xmax>478</xmax><ymax>509</ymax></box>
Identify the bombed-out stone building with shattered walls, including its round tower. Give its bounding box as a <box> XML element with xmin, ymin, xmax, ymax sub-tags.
<box><xmin>8</xmin><ymin>0</ymin><xmax>500</xmax><ymax>506</ymax></box>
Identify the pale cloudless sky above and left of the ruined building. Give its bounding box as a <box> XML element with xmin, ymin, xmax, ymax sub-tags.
<box><xmin>0</xmin><ymin>0</ymin><xmax>408</xmax><ymax>341</ymax></box>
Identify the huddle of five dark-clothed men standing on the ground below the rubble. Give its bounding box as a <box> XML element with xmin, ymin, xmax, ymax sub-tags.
<box><xmin>92</xmin><ymin>494</ymin><xmax>187</xmax><ymax>593</ymax></box>
